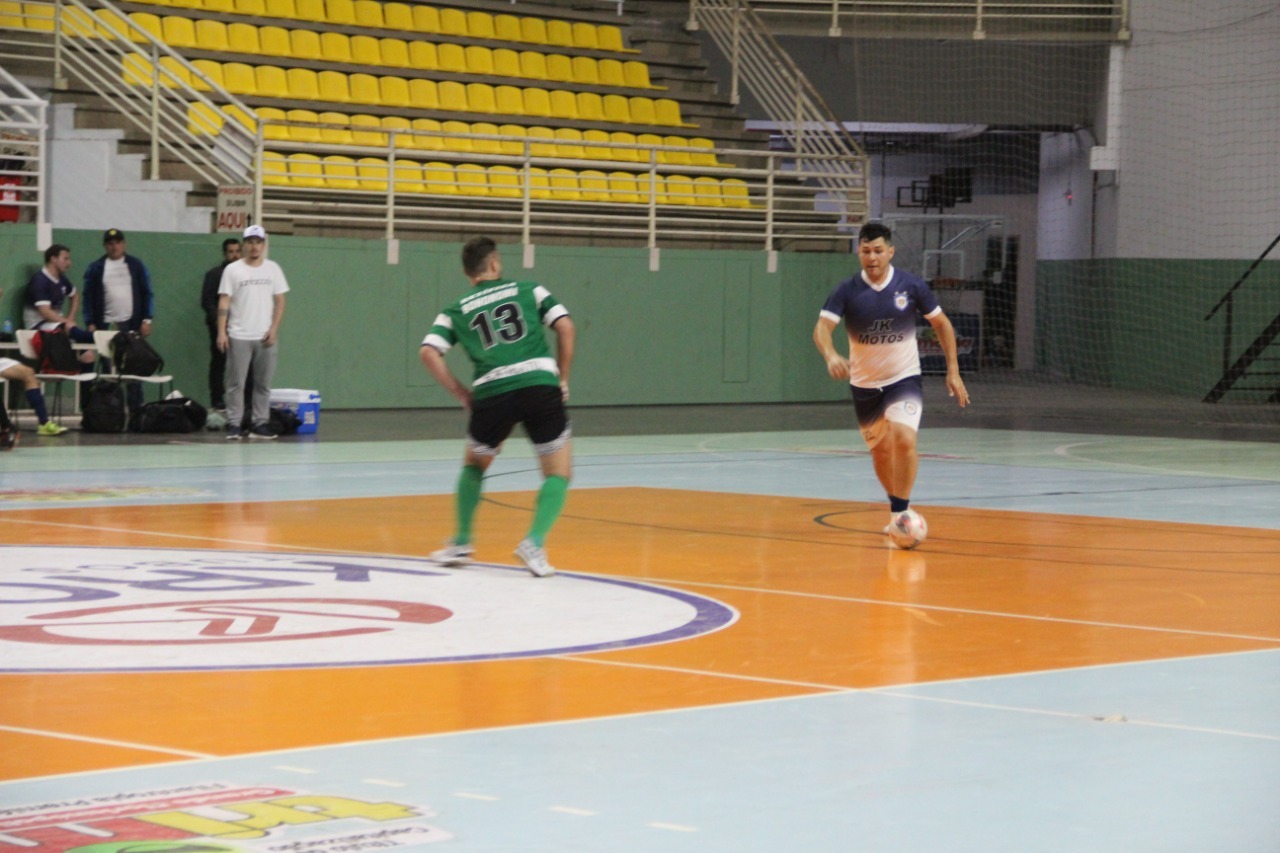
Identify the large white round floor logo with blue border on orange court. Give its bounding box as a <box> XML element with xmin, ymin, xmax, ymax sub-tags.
<box><xmin>0</xmin><ymin>546</ymin><xmax>737</xmax><ymax>672</ymax></box>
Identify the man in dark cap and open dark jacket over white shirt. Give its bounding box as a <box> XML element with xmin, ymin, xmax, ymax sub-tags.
<box><xmin>84</xmin><ymin>228</ymin><xmax>155</xmax><ymax>411</ymax></box>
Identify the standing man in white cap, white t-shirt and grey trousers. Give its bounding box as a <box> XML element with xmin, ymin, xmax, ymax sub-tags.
<box><xmin>218</xmin><ymin>225</ymin><xmax>289</xmax><ymax>441</ymax></box>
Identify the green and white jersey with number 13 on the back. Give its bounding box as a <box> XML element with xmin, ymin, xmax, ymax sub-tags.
<box><xmin>422</xmin><ymin>280</ymin><xmax>568</xmax><ymax>400</ymax></box>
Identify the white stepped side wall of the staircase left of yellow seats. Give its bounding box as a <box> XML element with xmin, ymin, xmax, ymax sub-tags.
<box><xmin>49</xmin><ymin>104</ymin><xmax>214</xmax><ymax>234</ymax></box>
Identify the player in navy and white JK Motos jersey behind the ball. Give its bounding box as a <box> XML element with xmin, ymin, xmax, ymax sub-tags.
<box><xmin>813</xmin><ymin>223</ymin><xmax>969</xmax><ymax>532</ymax></box>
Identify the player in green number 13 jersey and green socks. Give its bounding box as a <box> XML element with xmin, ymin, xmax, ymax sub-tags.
<box><xmin>421</xmin><ymin>237</ymin><xmax>575</xmax><ymax>578</ymax></box>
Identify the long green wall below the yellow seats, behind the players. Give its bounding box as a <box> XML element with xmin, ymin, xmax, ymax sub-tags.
<box><xmin>0</xmin><ymin>225</ymin><xmax>856</xmax><ymax>409</ymax></box>
